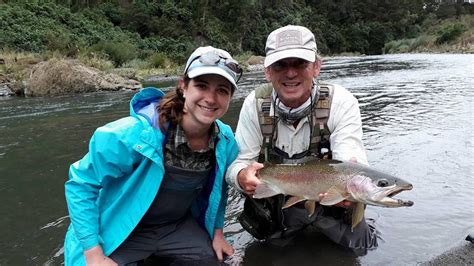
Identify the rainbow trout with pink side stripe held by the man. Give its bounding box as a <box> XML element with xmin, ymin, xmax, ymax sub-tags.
<box><xmin>253</xmin><ymin>159</ymin><xmax>413</xmax><ymax>228</ymax></box>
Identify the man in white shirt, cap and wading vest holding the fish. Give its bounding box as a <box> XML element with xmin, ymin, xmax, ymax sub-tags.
<box><xmin>226</xmin><ymin>25</ymin><xmax>377</xmax><ymax>249</ymax></box>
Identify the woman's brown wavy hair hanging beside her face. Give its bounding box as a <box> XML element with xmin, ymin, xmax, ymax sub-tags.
<box><xmin>157</xmin><ymin>77</ymin><xmax>191</xmax><ymax>132</ymax></box>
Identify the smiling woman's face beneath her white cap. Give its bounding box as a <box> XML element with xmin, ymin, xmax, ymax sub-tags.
<box><xmin>182</xmin><ymin>74</ymin><xmax>232</xmax><ymax>127</ymax></box>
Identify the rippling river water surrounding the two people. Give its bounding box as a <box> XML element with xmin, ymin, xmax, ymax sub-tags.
<box><xmin>0</xmin><ymin>54</ymin><xmax>474</xmax><ymax>266</ymax></box>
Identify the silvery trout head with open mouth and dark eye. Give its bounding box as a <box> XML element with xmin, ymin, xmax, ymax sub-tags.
<box><xmin>346</xmin><ymin>173</ymin><xmax>413</xmax><ymax>207</ymax></box>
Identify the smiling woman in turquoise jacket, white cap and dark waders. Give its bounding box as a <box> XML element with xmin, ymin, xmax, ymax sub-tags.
<box><xmin>64</xmin><ymin>46</ymin><xmax>242</xmax><ymax>265</ymax></box>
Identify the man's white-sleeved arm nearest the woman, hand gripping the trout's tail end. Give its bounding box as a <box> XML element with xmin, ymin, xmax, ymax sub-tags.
<box><xmin>226</xmin><ymin>91</ymin><xmax>263</xmax><ymax>194</ymax></box>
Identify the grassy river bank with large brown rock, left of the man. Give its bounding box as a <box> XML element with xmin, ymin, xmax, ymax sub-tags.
<box><xmin>0</xmin><ymin>52</ymin><xmax>264</xmax><ymax>96</ymax></box>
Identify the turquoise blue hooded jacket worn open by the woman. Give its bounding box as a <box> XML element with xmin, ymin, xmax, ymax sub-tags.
<box><xmin>64</xmin><ymin>88</ymin><xmax>238</xmax><ymax>265</ymax></box>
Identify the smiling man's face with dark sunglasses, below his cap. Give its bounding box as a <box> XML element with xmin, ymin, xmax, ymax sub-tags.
<box><xmin>265</xmin><ymin>58</ymin><xmax>321</xmax><ymax>108</ymax></box>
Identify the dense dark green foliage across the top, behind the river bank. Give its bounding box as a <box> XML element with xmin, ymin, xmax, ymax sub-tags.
<box><xmin>0</xmin><ymin>0</ymin><xmax>474</xmax><ymax>66</ymax></box>
